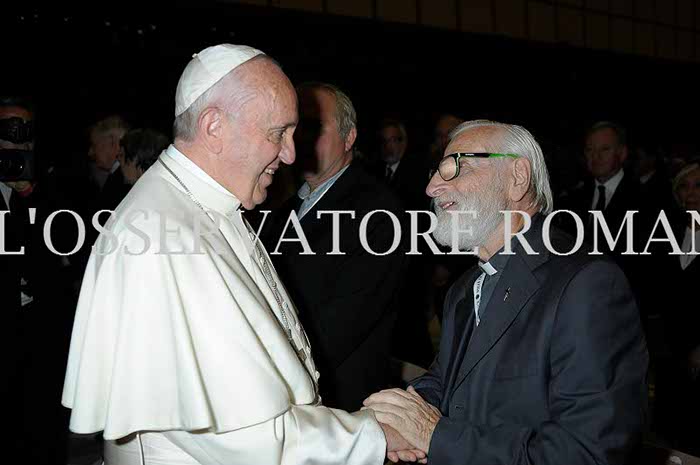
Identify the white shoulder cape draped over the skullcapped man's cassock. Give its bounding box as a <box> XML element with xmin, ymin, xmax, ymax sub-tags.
<box><xmin>62</xmin><ymin>160</ymin><xmax>314</xmax><ymax>439</ymax></box>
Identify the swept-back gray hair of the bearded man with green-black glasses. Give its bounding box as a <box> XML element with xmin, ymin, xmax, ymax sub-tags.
<box><xmin>450</xmin><ymin>119</ymin><xmax>554</xmax><ymax>215</ymax></box>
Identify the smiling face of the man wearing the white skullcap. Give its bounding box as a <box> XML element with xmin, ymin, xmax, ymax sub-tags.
<box><xmin>224</xmin><ymin>60</ymin><xmax>297</xmax><ymax>210</ymax></box>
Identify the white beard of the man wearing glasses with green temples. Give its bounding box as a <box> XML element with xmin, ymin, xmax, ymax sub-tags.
<box><xmin>433</xmin><ymin>182</ymin><xmax>507</xmax><ymax>251</ymax></box>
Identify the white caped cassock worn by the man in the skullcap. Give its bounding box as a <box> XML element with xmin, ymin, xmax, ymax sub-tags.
<box><xmin>63</xmin><ymin>146</ymin><xmax>386</xmax><ymax>465</ymax></box>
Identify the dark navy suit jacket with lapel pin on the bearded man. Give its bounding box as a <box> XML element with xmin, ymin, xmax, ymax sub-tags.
<box><xmin>413</xmin><ymin>215</ymin><xmax>648</xmax><ymax>465</ymax></box>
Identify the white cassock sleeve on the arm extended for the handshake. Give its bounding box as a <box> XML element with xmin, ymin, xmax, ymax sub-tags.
<box><xmin>163</xmin><ymin>405</ymin><xmax>386</xmax><ymax>465</ymax></box>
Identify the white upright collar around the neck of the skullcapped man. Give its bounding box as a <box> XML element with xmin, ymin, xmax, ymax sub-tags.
<box><xmin>162</xmin><ymin>145</ymin><xmax>241</xmax><ymax>215</ymax></box>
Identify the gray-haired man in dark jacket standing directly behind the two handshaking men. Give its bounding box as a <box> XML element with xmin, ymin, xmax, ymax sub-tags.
<box><xmin>262</xmin><ymin>82</ymin><xmax>408</xmax><ymax>411</ymax></box>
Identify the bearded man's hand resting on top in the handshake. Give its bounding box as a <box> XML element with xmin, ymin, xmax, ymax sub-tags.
<box><xmin>364</xmin><ymin>386</ymin><xmax>441</xmax><ymax>458</ymax></box>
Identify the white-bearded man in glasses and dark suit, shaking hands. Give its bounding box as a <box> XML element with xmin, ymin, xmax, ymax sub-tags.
<box><xmin>366</xmin><ymin>121</ymin><xmax>648</xmax><ymax>465</ymax></box>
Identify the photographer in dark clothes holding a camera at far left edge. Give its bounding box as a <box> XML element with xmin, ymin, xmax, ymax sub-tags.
<box><xmin>0</xmin><ymin>96</ymin><xmax>74</xmax><ymax>465</ymax></box>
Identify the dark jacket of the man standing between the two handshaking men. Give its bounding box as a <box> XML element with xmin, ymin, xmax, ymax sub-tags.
<box><xmin>261</xmin><ymin>164</ymin><xmax>406</xmax><ymax>411</ymax></box>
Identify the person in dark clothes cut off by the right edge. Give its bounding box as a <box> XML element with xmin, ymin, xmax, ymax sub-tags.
<box><xmin>654</xmin><ymin>160</ymin><xmax>700</xmax><ymax>455</ymax></box>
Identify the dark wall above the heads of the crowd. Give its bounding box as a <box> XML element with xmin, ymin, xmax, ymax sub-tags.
<box><xmin>0</xmin><ymin>2</ymin><xmax>700</xmax><ymax>192</ymax></box>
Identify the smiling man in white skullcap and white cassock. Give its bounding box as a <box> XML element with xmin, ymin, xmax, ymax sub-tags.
<box><xmin>63</xmin><ymin>45</ymin><xmax>424</xmax><ymax>465</ymax></box>
